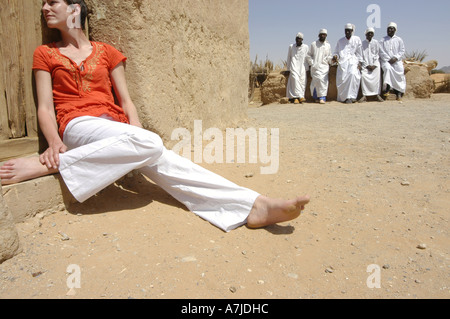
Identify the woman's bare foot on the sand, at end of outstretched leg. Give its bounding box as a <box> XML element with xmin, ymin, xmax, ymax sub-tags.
<box><xmin>247</xmin><ymin>196</ymin><xmax>310</xmax><ymax>228</ymax></box>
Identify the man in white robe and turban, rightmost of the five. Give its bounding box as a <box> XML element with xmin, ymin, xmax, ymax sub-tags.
<box><xmin>380</xmin><ymin>22</ymin><xmax>406</xmax><ymax>101</ymax></box>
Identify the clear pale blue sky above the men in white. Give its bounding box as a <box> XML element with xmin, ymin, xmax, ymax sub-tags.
<box><xmin>249</xmin><ymin>0</ymin><xmax>450</xmax><ymax>69</ymax></box>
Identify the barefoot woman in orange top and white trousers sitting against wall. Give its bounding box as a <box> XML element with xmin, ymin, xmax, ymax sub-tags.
<box><xmin>0</xmin><ymin>0</ymin><xmax>309</xmax><ymax>231</ymax></box>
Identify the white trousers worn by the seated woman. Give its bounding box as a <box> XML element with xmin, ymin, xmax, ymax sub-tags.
<box><xmin>59</xmin><ymin>116</ymin><xmax>260</xmax><ymax>232</ymax></box>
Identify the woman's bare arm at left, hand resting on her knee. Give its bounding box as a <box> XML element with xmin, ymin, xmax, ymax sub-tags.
<box><xmin>34</xmin><ymin>70</ymin><xmax>67</xmax><ymax>169</ymax></box>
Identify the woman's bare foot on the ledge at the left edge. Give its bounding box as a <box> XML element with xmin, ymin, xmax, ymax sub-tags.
<box><xmin>0</xmin><ymin>156</ymin><xmax>58</xmax><ymax>185</ymax></box>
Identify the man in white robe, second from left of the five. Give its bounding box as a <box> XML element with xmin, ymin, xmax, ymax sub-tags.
<box><xmin>306</xmin><ymin>29</ymin><xmax>332</xmax><ymax>104</ymax></box>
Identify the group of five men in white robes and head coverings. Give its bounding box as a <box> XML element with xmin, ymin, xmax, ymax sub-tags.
<box><xmin>286</xmin><ymin>22</ymin><xmax>406</xmax><ymax>104</ymax></box>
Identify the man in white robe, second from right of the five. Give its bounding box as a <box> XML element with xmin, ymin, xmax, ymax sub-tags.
<box><xmin>359</xmin><ymin>28</ymin><xmax>384</xmax><ymax>103</ymax></box>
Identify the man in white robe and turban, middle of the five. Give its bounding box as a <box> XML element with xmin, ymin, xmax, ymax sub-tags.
<box><xmin>333</xmin><ymin>23</ymin><xmax>362</xmax><ymax>103</ymax></box>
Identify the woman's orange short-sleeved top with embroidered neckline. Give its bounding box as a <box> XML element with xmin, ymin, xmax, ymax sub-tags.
<box><xmin>33</xmin><ymin>42</ymin><xmax>129</xmax><ymax>138</ymax></box>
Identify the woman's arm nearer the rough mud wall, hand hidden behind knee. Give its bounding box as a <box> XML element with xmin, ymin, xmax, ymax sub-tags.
<box><xmin>111</xmin><ymin>62</ymin><xmax>142</xmax><ymax>127</ymax></box>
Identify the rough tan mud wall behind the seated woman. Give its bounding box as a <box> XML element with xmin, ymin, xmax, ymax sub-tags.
<box><xmin>86</xmin><ymin>0</ymin><xmax>249</xmax><ymax>142</ymax></box>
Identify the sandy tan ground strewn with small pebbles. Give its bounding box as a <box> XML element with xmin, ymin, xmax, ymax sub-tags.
<box><xmin>0</xmin><ymin>95</ymin><xmax>450</xmax><ymax>299</ymax></box>
